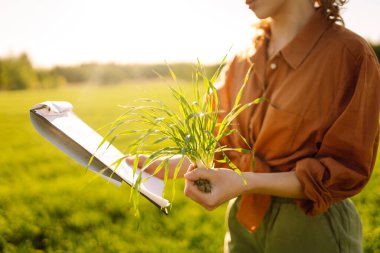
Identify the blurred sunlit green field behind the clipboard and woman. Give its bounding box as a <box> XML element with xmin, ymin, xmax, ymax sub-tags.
<box><xmin>0</xmin><ymin>82</ymin><xmax>380</xmax><ymax>252</ymax></box>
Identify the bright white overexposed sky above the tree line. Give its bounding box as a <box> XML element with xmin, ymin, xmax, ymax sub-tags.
<box><xmin>0</xmin><ymin>0</ymin><xmax>380</xmax><ymax>67</ymax></box>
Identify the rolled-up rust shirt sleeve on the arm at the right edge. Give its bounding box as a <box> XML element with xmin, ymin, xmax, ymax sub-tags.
<box><xmin>295</xmin><ymin>55</ymin><xmax>380</xmax><ymax>215</ymax></box>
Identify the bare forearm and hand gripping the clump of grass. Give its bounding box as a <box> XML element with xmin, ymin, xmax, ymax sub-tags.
<box><xmin>184</xmin><ymin>166</ymin><xmax>305</xmax><ymax>210</ymax></box>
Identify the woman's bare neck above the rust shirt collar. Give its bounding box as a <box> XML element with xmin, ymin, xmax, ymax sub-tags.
<box><xmin>268</xmin><ymin>0</ymin><xmax>315</xmax><ymax>59</ymax></box>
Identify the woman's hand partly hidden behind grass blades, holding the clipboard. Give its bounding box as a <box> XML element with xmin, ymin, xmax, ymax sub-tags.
<box><xmin>125</xmin><ymin>155</ymin><xmax>190</xmax><ymax>179</ymax></box>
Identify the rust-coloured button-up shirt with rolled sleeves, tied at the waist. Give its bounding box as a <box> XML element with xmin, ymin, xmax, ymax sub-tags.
<box><xmin>220</xmin><ymin>11</ymin><xmax>380</xmax><ymax>230</ymax></box>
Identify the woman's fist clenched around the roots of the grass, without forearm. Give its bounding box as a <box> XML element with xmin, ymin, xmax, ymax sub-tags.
<box><xmin>184</xmin><ymin>166</ymin><xmax>247</xmax><ymax>211</ymax></box>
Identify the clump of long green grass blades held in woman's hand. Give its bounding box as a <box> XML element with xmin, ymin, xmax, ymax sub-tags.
<box><xmin>99</xmin><ymin>55</ymin><xmax>262</xmax><ymax>211</ymax></box>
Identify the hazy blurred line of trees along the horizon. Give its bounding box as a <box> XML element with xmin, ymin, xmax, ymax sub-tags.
<box><xmin>0</xmin><ymin>44</ymin><xmax>380</xmax><ymax>90</ymax></box>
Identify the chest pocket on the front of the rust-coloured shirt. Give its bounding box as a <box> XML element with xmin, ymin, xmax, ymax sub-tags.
<box><xmin>255</xmin><ymin>105</ymin><xmax>303</xmax><ymax>160</ymax></box>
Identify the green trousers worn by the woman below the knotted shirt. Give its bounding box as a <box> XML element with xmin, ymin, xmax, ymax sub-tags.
<box><xmin>224</xmin><ymin>198</ymin><xmax>363</xmax><ymax>253</ymax></box>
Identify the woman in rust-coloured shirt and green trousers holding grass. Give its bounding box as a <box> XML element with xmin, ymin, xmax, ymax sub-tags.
<box><xmin>128</xmin><ymin>0</ymin><xmax>380</xmax><ymax>253</ymax></box>
